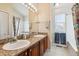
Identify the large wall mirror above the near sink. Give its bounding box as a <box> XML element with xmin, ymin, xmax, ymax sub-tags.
<box><xmin>0</xmin><ymin>4</ymin><xmax>29</xmax><ymax>39</ymax></box>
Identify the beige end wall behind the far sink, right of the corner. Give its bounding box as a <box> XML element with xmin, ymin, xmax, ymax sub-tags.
<box><xmin>38</xmin><ymin>3</ymin><xmax>51</xmax><ymax>32</ymax></box>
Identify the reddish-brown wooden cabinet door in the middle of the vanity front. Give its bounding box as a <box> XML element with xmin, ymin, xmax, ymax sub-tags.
<box><xmin>29</xmin><ymin>43</ymin><xmax>39</xmax><ymax>56</ymax></box>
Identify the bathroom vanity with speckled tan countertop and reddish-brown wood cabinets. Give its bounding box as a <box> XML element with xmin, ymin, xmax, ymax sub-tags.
<box><xmin>0</xmin><ymin>35</ymin><xmax>49</xmax><ymax>56</ymax></box>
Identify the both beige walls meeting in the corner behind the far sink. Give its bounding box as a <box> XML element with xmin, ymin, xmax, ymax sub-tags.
<box><xmin>29</xmin><ymin>3</ymin><xmax>52</xmax><ymax>47</ymax></box>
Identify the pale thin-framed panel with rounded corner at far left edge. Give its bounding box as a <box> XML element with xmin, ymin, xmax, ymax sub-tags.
<box><xmin>0</xmin><ymin>11</ymin><xmax>9</xmax><ymax>37</ymax></box>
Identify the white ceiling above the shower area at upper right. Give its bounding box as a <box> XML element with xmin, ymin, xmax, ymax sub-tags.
<box><xmin>54</xmin><ymin>3</ymin><xmax>74</xmax><ymax>14</ymax></box>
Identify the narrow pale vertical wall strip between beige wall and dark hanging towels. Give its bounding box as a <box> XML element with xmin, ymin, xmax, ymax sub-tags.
<box><xmin>49</xmin><ymin>3</ymin><xmax>55</xmax><ymax>46</ymax></box>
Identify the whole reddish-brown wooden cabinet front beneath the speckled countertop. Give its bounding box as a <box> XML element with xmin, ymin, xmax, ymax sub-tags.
<box><xmin>18</xmin><ymin>36</ymin><xmax>48</xmax><ymax>56</ymax></box>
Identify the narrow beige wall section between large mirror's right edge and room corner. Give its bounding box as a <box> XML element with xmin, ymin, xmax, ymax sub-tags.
<box><xmin>29</xmin><ymin>7</ymin><xmax>38</xmax><ymax>32</ymax></box>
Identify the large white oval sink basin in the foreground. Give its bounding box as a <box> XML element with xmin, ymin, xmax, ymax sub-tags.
<box><xmin>2</xmin><ymin>40</ymin><xmax>30</xmax><ymax>50</ymax></box>
